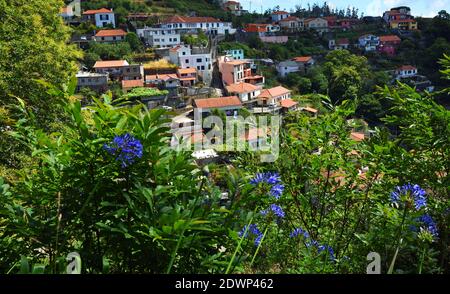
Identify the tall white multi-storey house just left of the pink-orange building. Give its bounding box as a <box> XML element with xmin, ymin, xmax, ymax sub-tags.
<box><xmin>169</xmin><ymin>45</ymin><xmax>213</xmax><ymax>84</ymax></box>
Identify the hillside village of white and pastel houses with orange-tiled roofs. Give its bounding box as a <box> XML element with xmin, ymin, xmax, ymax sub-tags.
<box><xmin>61</xmin><ymin>1</ymin><xmax>446</xmax><ymax>160</ymax></box>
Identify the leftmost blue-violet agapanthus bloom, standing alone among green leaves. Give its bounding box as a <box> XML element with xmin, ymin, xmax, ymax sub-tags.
<box><xmin>103</xmin><ymin>133</ymin><xmax>143</xmax><ymax>167</ymax></box>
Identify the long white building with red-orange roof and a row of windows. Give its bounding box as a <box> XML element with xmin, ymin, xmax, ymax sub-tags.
<box><xmin>160</xmin><ymin>15</ymin><xmax>236</xmax><ymax>35</ymax></box>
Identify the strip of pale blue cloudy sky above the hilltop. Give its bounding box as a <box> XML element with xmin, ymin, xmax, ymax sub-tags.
<box><xmin>238</xmin><ymin>0</ymin><xmax>450</xmax><ymax>17</ymax></box>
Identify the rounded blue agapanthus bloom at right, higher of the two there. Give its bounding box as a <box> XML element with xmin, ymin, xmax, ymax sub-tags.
<box><xmin>391</xmin><ymin>184</ymin><xmax>427</xmax><ymax>210</ymax></box>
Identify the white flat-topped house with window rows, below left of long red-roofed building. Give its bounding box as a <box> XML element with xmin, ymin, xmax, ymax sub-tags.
<box><xmin>136</xmin><ymin>27</ymin><xmax>181</xmax><ymax>48</ymax></box>
